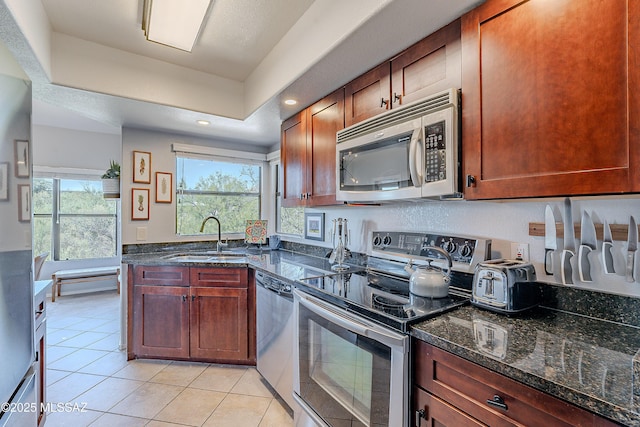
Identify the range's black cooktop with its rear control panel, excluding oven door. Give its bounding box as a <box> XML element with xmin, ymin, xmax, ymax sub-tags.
<box><xmin>301</xmin><ymin>231</ymin><xmax>491</xmax><ymax>332</ymax></box>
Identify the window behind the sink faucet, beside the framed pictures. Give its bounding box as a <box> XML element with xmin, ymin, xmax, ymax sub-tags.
<box><xmin>176</xmin><ymin>156</ymin><xmax>262</xmax><ymax>235</ymax></box>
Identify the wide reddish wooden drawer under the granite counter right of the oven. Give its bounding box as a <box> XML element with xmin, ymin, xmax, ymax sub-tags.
<box><xmin>414</xmin><ymin>340</ymin><xmax>617</xmax><ymax>426</ymax></box>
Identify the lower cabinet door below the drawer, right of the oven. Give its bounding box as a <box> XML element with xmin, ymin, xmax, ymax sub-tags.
<box><xmin>411</xmin><ymin>387</ymin><xmax>486</xmax><ymax>427</ymax></box>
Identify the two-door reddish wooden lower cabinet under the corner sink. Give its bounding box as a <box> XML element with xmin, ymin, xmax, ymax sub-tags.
<box><xmin>128</xmin><ymin>266</ymin><xmax>255</xmax><ymax>364</ymax></box>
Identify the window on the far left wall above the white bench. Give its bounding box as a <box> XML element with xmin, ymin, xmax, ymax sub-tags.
<box><xmin>33</xmin><ymin>178</ymin><xmax>118</xmax><ymax>261</ymax></box>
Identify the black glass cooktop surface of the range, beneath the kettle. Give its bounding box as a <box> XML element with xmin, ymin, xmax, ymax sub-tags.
<box><xmin>300</xmin><ymin>271</ymin><xmax>470</xmax><ymax>332</ymax></box>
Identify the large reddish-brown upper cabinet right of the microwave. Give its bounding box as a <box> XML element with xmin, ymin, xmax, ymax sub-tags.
<box><xmin>462</xmin><ymin>0</ymin><xmax>640</xmax><ymax>199</ymax></box>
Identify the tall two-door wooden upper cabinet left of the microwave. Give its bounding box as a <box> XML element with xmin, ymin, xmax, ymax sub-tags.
<box><xmin>280</xmin><ymin>88</ymin><xmax>344</xmax><ymax>207</ymax></box>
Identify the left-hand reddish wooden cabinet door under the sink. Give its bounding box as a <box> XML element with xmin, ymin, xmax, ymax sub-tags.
<box><xmin>132</xmin><ymin>285</ymin><xmax>189</xmax><ymax>358</ymax></box>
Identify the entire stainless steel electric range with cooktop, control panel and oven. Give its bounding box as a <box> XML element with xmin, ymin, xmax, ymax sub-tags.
<box><xmin>293</xmin><ymin>232</ymin><xmax>491</xmax><ymax>427</ymax></box>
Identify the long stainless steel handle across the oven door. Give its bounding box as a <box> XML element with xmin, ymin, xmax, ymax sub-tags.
<box><xmin>294</xmin><ymin>289</ymin><xmax>407</xmax><ymax>347</ymax></box>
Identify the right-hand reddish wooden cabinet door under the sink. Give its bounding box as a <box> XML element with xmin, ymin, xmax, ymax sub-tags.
<box><xmin>191</xmin><ymin>288</ymin><xmax>249</xmax><ymax>362</ymax></box>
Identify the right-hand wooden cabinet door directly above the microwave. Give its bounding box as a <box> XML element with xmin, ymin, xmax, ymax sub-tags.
<box><xmin>391</xmin><ymin>19</ymin><xmax>462</xmax><ymax>108</ymax></box>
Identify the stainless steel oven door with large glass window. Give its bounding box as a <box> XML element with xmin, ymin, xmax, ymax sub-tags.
<box><xmin>294</xmin><ymin>289</ymin><xmax>409</xmax><ymax>427</ymax></box>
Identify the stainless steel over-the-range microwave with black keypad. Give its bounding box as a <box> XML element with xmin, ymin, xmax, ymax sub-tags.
<box><xmin>336</xmin><ymin>89</ymin><xmax>462</xmax><ymax>203</ymax></box>
